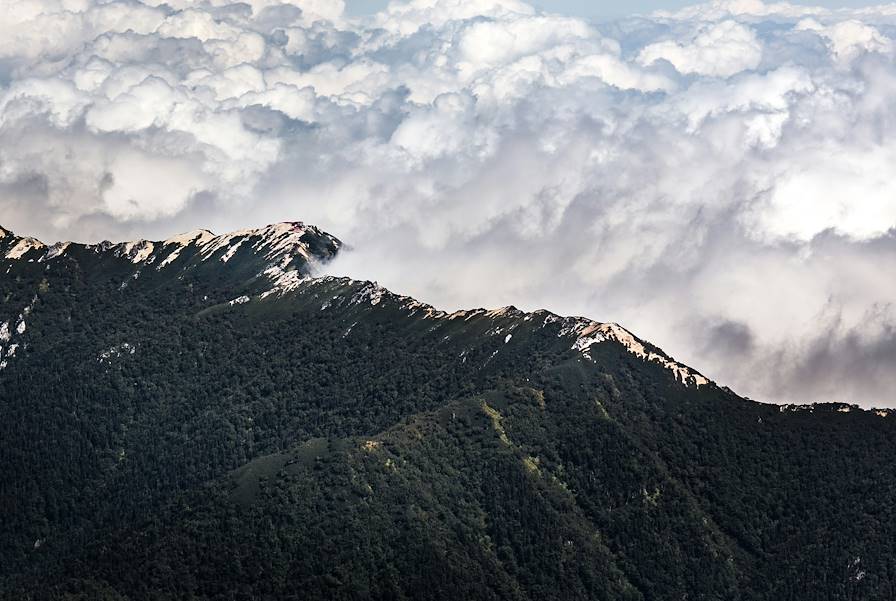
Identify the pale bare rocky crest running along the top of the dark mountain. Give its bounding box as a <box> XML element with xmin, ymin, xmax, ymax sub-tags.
<box><xmin>0</xmin><ymin>221</ymin><xmax>891</xmax><ymax>417</ymax></box>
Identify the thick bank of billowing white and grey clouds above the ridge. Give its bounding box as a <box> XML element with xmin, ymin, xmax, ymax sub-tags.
<box><xmin>0</xmin><ymin>0</ymin><xmax>896</xmax><ymax>406</ymax></box>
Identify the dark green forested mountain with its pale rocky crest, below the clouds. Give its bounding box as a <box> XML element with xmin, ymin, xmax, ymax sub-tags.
<box><xmin>0</xmin><ymin>226</ymin><xmax>896</xmax><ymax>601</ymax></box>
